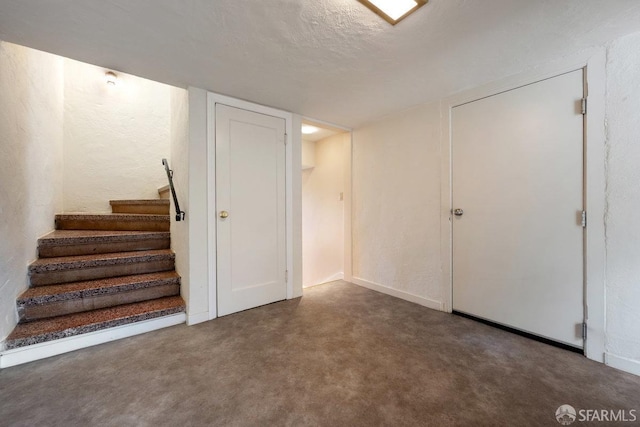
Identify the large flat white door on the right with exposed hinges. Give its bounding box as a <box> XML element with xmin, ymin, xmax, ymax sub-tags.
<box><xmin>452</xmin><ymin>70</ymin><xmax>584</xmax><ymax>347</ymax></box>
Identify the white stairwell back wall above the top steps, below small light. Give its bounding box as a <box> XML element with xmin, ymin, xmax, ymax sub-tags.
<box><xmin>64</xmin><ymin>59</ymin><xmax>171</xmax><ymax>212</ymax></box>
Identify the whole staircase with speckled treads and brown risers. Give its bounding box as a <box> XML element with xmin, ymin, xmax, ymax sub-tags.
<box><xmin>5</xmin><ymin>199</ymin><xmax>185</xmax><ymax>350</ymax></box>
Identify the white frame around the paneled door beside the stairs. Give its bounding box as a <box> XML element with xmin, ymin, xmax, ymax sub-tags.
<box><xmin>207</xmin><ymin>92</ymin><xmax>296</xmax><ymax>319</ymax></box>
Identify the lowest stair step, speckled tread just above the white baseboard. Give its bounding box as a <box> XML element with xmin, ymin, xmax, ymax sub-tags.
<box><xmin>6</xmin><ymin>296</ymin><xmax>185</xmax><ymax>350</ymax></box>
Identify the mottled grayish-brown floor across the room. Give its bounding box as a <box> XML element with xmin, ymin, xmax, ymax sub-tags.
<box><xmin>0</xmin><ymin>282</ymin><xmax>640</xmax><ymax>426</ymax></box>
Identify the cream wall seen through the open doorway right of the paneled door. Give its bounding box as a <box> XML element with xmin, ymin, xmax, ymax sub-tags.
<box><xmin>302</xmin><ymin>133</ymin><xmax>344</xmax><ymax>287</ymax></box>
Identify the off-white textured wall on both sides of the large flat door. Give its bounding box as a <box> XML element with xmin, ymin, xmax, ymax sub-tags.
<box><xmin>352</xmin><ymin>33</ymin><xmax>640</xmax><ymax>374</ymax></box>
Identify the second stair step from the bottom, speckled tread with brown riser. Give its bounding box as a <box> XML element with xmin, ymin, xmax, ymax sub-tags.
<box><xmin>17</xmin><ymin>271</ymin><xmax>180</xmax><ymax>322</ymax></box>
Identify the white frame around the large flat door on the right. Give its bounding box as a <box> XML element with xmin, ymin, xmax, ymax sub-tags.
<box><xmin>440</xmin><ymin>48</ymin><xmax>606</xmax><ymax>363</ymax></box>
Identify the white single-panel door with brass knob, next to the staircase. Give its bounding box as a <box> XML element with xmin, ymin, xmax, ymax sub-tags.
<box><xmin>216</xmin><ymin>104</ymin><xmax>286</xmax><ymax>316</ymax></box>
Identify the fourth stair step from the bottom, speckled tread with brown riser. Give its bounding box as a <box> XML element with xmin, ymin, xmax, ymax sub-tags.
<box><xmin>38</xmin><ymin>230</ymin><xmax>171</xmax><ymax>258</ymax></box>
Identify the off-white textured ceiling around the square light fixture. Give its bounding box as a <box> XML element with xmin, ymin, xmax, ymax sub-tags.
<box><xmin>0</xmin><ymin>0</ymin><xmax>640</xmax><ymax>126</ymax></box>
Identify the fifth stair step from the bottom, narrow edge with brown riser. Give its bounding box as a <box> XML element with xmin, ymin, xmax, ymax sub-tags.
<box><xmin>56</xmin><ymin>214</ymin><xmax>170</xmax><ymax>231</ymax></box>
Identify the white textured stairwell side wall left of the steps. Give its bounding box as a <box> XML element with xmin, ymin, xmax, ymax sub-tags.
<box><xmin>0</xmin><ymin>42</ymin><xmax>64</xmax><ymax>341</ymax></box>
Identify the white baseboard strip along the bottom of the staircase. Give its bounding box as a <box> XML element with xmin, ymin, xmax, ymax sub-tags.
<box><xmin>0</xmin><ymin>313</ymin><xmax>187</xmax><ymax>369</ymax></box>
